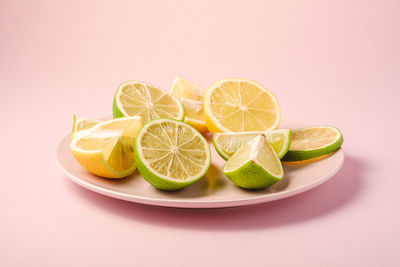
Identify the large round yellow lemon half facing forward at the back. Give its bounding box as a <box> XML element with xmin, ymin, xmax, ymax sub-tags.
<box><xmin>204</xmin><ymin>78</ymin><xmax>281</xmax><ymax>132</ymax></box>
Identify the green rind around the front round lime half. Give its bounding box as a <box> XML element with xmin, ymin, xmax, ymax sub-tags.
<box><xmin>135</xmin><ymin>118</ymin><xmax>211</xmax><ymax>191</ymax></box>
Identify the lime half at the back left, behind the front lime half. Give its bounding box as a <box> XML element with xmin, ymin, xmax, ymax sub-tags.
<box><xmin>113</xmin><ymin>81</ymin><xmax>184</xmax><ymax>123</ymax></box>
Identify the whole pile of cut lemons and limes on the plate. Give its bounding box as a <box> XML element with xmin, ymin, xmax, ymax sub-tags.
<box><xmin>70</xmin><ymin>77</ymin><xmax>343</xmax><ymax>190</ymax></box>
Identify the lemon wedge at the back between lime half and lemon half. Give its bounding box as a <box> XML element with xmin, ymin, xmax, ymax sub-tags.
<box><xmin>171</xmin><ymin>77</ymin><xmax>208</xmax><ymax>133</ymax></box>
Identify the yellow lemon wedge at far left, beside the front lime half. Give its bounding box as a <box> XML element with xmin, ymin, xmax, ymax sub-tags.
<box><xmin>70</xmin><ymin>116</ymin><xmax>142</xmax><ymax>178</ymax></box>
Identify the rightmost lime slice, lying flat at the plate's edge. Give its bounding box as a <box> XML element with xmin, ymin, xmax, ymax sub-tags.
<box><xmin>282</xmin><ymin>126</ymin><xmax>343</xmax><ymax>161</ymax></box>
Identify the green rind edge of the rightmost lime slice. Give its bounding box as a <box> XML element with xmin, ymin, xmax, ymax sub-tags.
<box><xmin>282</xmin><ymin>127</ymin><xmax>343</xmax><ymax>162</ymax></box>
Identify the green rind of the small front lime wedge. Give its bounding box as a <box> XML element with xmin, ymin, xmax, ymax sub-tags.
<box><xmin>224</xmin><ymin>160</ymin><xmax>282</xmax><ymax>189</ymax></box>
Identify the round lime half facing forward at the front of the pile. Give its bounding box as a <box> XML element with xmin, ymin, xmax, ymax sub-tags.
<box><xmin>135</xmin><ymin>119</ymin><xmax>211</xmax><ymax>190</ymax></box>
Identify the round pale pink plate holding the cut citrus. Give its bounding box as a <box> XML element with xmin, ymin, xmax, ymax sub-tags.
<box><xmin>55</xmin><ymin>118</ymin><xmax>344</xmax><ymax>208</ymax></box>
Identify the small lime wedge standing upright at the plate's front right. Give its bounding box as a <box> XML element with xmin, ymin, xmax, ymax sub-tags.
<box><xmin>224</xmin><ymin>135</ymin><xmax>283</xmax><ymax>189</ymax></box>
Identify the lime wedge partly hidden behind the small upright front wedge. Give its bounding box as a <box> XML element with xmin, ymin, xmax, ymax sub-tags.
<box><xmin>212</xmin><ymin>129</ymin><xmax>292</xmax><ymax>160</ymax></box>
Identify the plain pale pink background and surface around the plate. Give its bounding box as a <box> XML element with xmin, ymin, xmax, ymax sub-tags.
<box><xmin>0</xmin><ymin>0</ymin><xmax>400</xmax><ymax>266</ymax></box>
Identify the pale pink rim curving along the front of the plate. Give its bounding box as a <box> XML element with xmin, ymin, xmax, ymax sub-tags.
<box><xmin>54</xmin><ymin>134</ymin><xmax>345</xmax><ymax>209</ymax></box>
